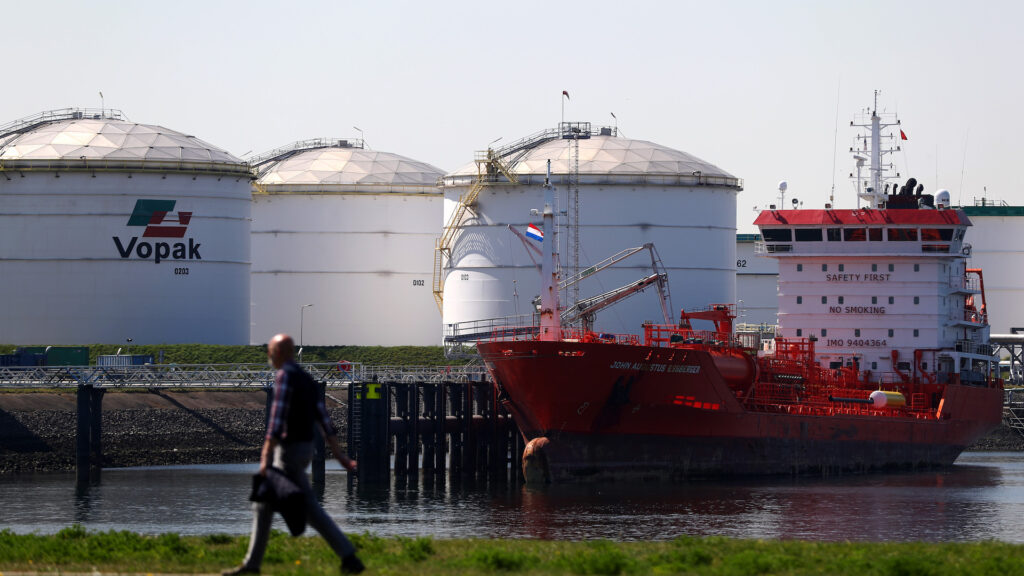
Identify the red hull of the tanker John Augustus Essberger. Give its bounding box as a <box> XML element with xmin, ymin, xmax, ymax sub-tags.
<box><xmin>478</xmin><ymin>341</ymin><xmax>1002</xmax><ymax>480</ymax></box>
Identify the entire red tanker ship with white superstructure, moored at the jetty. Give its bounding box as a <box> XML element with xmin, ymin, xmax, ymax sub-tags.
<box><xmin>477</xmin><ymin>105</ymin><xmax>1002</xmax><ymax>482</ymax></box>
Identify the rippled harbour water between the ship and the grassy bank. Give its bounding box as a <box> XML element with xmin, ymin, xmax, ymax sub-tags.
<box><xmin>0</xmin><ymin>452</ymin><xmax>1024</xmax><ymax>543</ymax></box>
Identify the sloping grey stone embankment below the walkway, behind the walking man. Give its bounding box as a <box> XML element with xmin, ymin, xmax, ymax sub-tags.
<box><xmin>0</xmin><ymin>390</ymin><xmax>346</xmax><ymax>475</ymax></box>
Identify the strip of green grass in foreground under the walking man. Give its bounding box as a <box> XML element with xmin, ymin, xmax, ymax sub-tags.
<box><xmin>0</xmin><ymin>526</ymin><xmax>1024</xmax><ymax>576</ymax></box>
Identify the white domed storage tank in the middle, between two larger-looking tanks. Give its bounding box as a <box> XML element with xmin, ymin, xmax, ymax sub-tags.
<box><xmin>251</xmin><ymin>138</ymin><xmax>443</xmax><ymax>345</ymax></box>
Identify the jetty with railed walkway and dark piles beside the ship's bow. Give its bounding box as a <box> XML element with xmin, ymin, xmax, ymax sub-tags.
<box><xmin>0</xmin><ymin>362</ymin><xmax>523</xmax><ymax>485</ymax></box>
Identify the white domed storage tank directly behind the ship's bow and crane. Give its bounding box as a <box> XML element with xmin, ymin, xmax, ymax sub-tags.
<box><xmin>442</xmin><ymin>123</ymin><xmax>742</xmax><ymax>334</ymax></box>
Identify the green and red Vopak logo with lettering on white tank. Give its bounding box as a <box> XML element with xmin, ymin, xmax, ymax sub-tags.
<box><xmin>114</xmin><ymin>200</ymin><xmax>203</xmax><ymax>260</ymax></box>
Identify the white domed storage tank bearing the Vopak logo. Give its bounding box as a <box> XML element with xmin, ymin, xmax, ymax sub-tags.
<box><xmin>0</xmin><ymin>109</ymin><xmax>252</xmax><ymax>344</ymax></box>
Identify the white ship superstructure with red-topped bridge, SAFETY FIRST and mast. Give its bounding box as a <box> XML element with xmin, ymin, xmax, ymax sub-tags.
<box><xmin>755</xmin><ymin>96</ymin><xmax>992</xmax><ymax>382</ymax></box>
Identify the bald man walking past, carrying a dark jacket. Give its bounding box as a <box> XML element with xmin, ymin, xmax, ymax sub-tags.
<box><xmin>223</xmin><ymin>334</ymin><xmax>364</xmax><ymax>576</ymax></box>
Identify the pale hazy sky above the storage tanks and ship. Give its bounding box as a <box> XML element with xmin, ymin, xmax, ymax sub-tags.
<box><xmin>6</xmin><ymin>0</ymin><xmax>1024</xmax><ymax>232</ymax></box>
